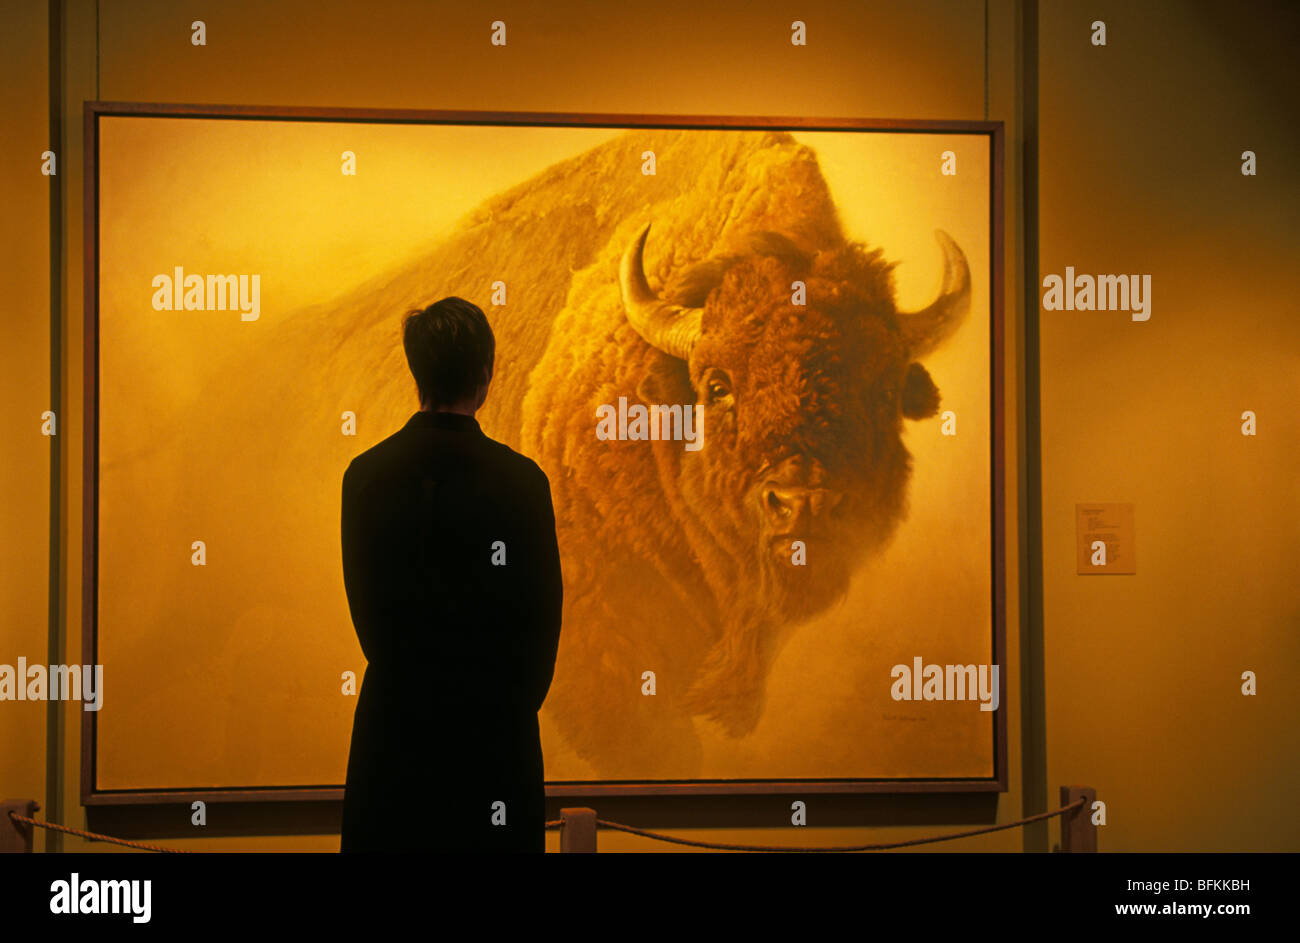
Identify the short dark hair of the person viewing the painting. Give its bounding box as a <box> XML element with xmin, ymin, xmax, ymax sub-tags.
<box><xmin>402</xmin><ymin>297</ymin><xmax>497</xmax><ymax>408</ymax></box>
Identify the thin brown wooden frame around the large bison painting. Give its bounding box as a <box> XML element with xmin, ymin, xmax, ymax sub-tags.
<box><xmin>81</xmin><ymin>101</ymin><xmax>1008</xmax><ymax>805</ymax></box>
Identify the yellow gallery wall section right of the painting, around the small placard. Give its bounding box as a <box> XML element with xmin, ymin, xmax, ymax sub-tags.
<box><xmin>1039</xmin><ymin>0</ymin><xmax>1300</xmax><ymax>852</ymax></box>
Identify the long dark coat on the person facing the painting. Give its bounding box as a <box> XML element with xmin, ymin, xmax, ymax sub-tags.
<box><xmin>341</xmin><ymin>412</ymin><xmax>563</xmax><ymax>852</ymax></box>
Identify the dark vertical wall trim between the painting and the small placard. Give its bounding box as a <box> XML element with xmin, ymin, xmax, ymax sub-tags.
<box><xmin>1017</xmin><ymin>0</ymin><xmax>1048</xmax><ymax>852</ymax></box>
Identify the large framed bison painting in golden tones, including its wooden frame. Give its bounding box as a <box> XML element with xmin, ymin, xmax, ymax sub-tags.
<box><xmin>82</xmin><ymin>103</ymin><xmax>1008</xmax><ymax>804</ymax></box>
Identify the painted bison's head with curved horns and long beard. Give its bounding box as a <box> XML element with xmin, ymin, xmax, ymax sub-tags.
<box><xmin>620</xmin><ymin>225</ymin><xmax>970</xmax><ymax>734</ymax></box>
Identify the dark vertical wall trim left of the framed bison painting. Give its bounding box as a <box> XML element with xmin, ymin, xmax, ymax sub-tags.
<box><xmin>42</xmin><ymin>0</ymin><xmax>69</xmax><ymax>853</ymax></box>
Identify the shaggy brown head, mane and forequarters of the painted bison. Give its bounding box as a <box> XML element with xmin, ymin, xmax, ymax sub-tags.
<box><xmin>467</xmin><ymin>131</ymin><xmax>970</xmax><ymax>773</ymax></box>
